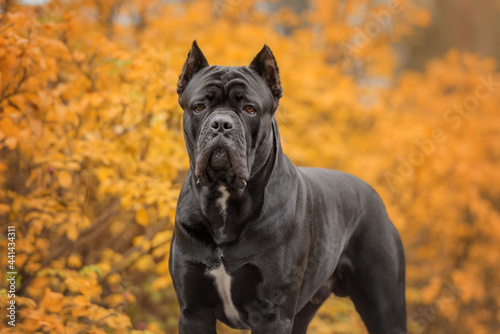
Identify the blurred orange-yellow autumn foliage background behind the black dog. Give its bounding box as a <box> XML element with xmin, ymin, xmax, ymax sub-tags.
<box><xmin>0</xmin><ymin>0</ymin><xmax>500</xmax><ymax>334</ymax></box>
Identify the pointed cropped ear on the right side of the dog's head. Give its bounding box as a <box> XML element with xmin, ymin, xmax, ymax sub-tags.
<box><xmin>249</xmin><ymin>45</ymin><xmax>283</xmax><ymax>99</ymax></box>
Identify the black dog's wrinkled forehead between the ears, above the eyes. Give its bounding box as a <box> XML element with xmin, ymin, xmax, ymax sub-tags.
<box><xmin>182</xmin><ymin>65</ymin><xmax>272</xmax><ymax>103</ymax></box>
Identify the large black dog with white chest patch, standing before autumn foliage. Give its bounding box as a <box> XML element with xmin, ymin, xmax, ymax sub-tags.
<box><xmin>170</xmin><ymin>41</ymin><xmax>406</xmax><ymax>334</ymax></box>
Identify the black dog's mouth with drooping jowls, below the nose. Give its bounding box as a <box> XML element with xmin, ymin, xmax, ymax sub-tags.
<box><xmin>195</xmin><ymin>141</ymin><xmax>248</xmax><ymax>189</ymax></box>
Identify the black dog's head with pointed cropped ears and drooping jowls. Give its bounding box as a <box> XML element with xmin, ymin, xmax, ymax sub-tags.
<box><xmin>177</xmin><ymin>41</ymin><xmax>282</xmax><ymax>191</ymax></box>
